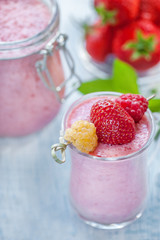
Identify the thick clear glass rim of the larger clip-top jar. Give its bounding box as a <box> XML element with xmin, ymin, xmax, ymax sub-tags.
<box><xmin>0</xmin><ymin>0</ymin><xmax>59</xmax><ymax>52</ymax></box>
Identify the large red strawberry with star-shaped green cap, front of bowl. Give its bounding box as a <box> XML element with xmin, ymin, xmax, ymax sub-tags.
<box><xmin>113</xmin><ymin>20</ymin><xmax>160</xmax><ymax>71</ymax></box>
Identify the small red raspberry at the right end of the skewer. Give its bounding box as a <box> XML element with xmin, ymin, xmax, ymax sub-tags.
<box><xmin>116</xmin><ymin>93</ymin><xmax>148</xmax><ymax>122</ymax></box>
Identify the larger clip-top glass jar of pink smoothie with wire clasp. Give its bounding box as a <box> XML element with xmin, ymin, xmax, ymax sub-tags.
<box><xmin>0</xmin><ymin>0</ymin><xmax>79</xmax><ymax>137</ymax></box>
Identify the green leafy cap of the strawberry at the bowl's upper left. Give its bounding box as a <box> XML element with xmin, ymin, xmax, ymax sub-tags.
<box><xmin>95</xmin><ymin>4</ymin><xmax>118</xmax><ymax>25</ymax></box>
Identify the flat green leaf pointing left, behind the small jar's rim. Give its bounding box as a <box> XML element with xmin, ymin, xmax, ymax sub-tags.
<box><xmin>78</xmin><ymin>79</ymin><xmax>114</xmax><ymax>94</ymax></box>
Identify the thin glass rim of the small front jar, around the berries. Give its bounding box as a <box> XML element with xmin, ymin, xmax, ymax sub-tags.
<box><xmin>61</xmin><ymin>91</ymin><xmax>155</xmax><ymax>162</ymax></box>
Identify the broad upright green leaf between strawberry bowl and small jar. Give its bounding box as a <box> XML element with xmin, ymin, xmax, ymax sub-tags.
<box><xmin>112</xmin><ymin>59</ymin><xmax>139</xmax><ymax>94</ymax></box>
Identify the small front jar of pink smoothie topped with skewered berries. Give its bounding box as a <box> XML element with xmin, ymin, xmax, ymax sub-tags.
<box><xmin>52</xmin><ymin>92</ymin><xmax>154</xmax><ymax>229</ymax></box>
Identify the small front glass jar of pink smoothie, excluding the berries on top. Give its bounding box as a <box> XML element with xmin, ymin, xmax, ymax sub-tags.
<box><xmin>61</xmin><ymin>92</ymin><xmax>154</xmax><ymax>229</ymax></box>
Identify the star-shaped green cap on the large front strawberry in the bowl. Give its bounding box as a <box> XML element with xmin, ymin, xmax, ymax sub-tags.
<box><xmin>123</xmin><ymin>30</ymin><xmax>157</xmax><ymax>61</ymax></box>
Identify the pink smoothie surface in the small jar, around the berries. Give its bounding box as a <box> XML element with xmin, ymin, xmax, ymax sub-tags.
<box><xmin>66</xmin><ymin>96</ymin><xmax>150</xmax><ymax>158</ymax></box>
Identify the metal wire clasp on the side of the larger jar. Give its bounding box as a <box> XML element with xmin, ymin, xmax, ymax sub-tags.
<box><xmin>35</xmin><ymin>33</ymin><xmax>82</xmax><ymax>103</ymax></box>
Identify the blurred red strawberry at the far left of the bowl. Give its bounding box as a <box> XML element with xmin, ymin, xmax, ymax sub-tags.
<box><xmin>85</xmin><ymin>20</ymin><xmax>111</xmax><ymax>62</ymax></box>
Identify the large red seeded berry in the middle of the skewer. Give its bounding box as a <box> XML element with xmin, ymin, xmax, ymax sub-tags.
<box><xmin>90</xmin><ymin>99</ymin><xmax>135</xmax><ymax>145</ymax></box>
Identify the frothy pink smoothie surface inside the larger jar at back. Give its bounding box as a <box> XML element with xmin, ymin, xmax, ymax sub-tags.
<box><xmin>0</xmin><ymin>0</ymin><xmax>51</xmax><ymax>42</ymax></box>
